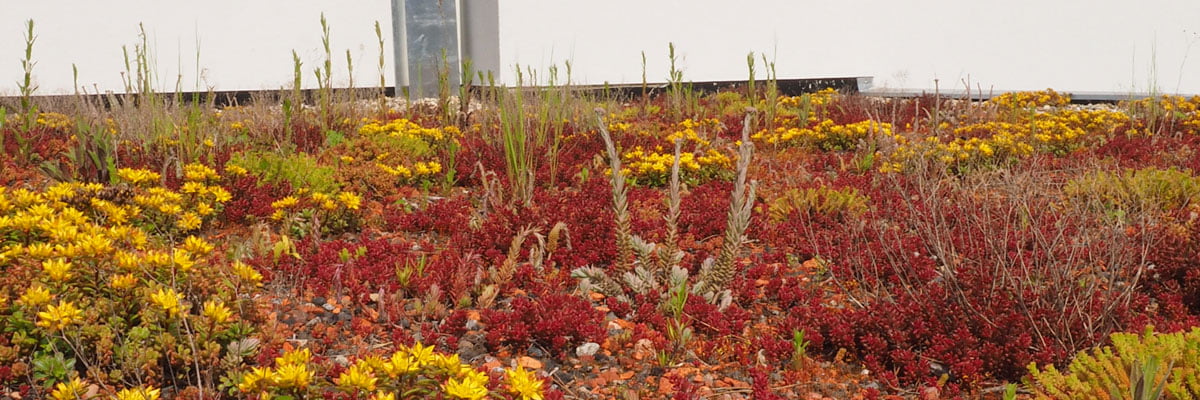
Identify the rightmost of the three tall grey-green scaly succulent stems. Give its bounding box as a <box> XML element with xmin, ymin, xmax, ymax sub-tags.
<box><xmin>695</xmin><ymin>107</ymin><xmax>758</xmax><ymax>303</ymax></box>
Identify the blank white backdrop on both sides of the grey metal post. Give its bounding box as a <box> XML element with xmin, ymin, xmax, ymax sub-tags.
<box><xmin>0</xmin><ymin>0</ymin><xmax>1200</xmax><ymax>95</ymax></box>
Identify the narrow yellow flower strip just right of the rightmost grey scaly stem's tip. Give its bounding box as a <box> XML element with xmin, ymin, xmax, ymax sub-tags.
<box><xmin>752</xmin><ymin>119</ymin><xmax>893</xmax><ymax>151</ymax></box>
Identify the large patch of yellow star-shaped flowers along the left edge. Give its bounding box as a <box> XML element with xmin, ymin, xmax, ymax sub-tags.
<box><xmin>0</xmin><ymin>168</ymin><xmax>248</xmax><ymax>400</ymax></box>
